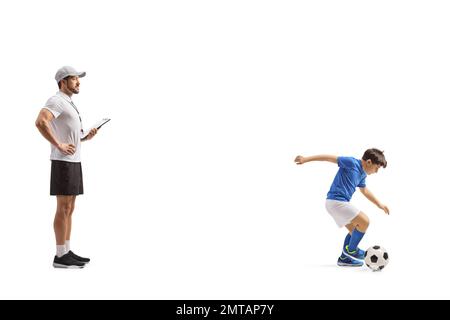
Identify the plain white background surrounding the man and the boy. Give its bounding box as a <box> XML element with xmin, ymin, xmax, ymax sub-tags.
<box><xmin>0</xmin><ymin>0</ymin><xmax>450</xmax><ymax>299</ymax></box>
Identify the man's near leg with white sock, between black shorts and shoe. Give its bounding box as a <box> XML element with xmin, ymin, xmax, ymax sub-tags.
<box><xmin>53</xmin><ymin>196</ymin><xmax>73</xmax><ymax>256</ymax></box>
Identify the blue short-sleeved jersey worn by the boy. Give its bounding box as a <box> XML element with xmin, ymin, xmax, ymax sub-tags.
<box><xmin>327</xmin><ymin>157</ymin><xmax>367</xmax><ymax>202</ymax></box>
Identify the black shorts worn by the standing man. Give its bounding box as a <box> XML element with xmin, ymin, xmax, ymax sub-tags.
<box><xmin>50</xmin><ymin>160</ymin><xmax>83</xmax><ymax>196</ymax></box>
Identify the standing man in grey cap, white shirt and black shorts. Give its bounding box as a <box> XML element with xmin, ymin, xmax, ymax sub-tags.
<box><xmin>36</xmin><ymin>66</ymin><xmax>97</xmax><ymax>268</ymax></box>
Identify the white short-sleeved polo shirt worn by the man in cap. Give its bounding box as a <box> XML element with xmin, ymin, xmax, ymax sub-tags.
<box><xmin>44</xmin><ymin>91</ymin><xmax>82</xmax><ymax>162</ymax></box>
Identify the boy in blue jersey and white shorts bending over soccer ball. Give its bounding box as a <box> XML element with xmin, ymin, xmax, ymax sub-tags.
<box><xmin>295</xmin><ymin>149</ymin><xmax>389</xmax><ymax>267</ymax></box>
